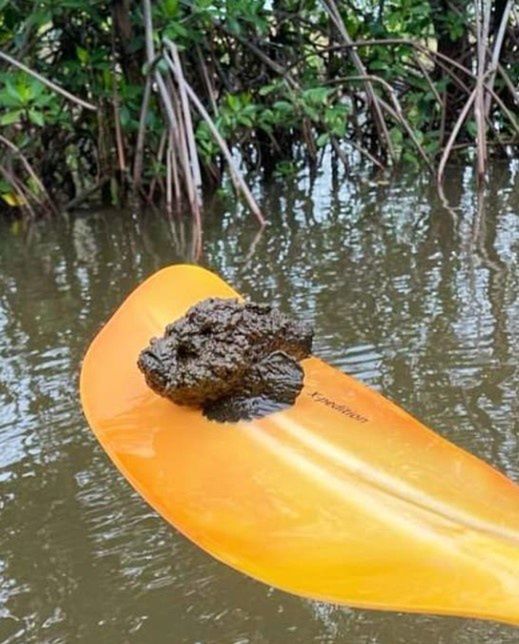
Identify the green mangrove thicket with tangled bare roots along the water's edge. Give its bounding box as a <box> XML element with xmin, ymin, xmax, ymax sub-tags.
<box><xmin>0</xmin><ymin>0</ymin><xmax>519</xmax><ymax>220</ymax></box>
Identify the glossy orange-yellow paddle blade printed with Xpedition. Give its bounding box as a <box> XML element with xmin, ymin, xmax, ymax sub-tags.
<box><xmin>81</xmin><ymin>265</ymin><xmax>519</xmax><ymax>624</ymax></box>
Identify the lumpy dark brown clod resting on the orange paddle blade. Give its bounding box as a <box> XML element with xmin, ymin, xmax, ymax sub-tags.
<box><xmin>138</xmin><ymin>298</ymin><xmax>313</xmax><ymax>422</ymax></box>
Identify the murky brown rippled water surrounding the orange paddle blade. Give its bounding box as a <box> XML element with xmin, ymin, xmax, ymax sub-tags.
<box><xmin>0</xmin><ymin>158</ymin><xmax>519</xmax><ymax>644</ymax></box>
